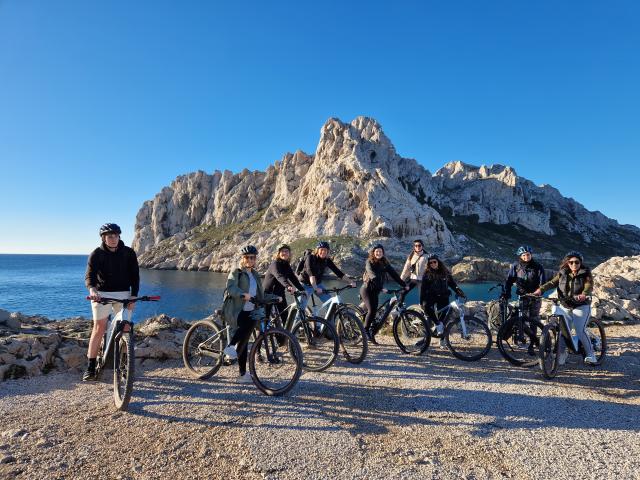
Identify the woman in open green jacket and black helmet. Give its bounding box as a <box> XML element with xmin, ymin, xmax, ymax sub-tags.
<box><xmin>224</xmin><ymin>245</ymin><xmax>282</xmax><ymax>383</ymax></box>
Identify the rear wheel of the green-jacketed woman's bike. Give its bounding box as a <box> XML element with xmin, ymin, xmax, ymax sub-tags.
<box><xmin>182</xmin><ymin>320</ymin><xmax>226</xmax><ymax>380</ymax></box>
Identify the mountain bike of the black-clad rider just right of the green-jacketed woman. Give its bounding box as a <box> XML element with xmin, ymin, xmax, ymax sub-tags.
<box><xmin>271</xmin><ymin>290</ymin><xmax>340</xmax><ymax>372</ymax></box>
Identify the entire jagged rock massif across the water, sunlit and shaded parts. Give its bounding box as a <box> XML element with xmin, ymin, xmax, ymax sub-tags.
<box><xmin>133</xmin><ymin>117</ymin><xmax>640</xmax><ymax>271</ymax></box>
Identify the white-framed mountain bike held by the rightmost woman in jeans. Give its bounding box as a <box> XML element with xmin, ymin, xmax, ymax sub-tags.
<box><xmin>539</xmin><ymin>298</ymin><xmax>607</xmax><ymax>379</ymax></box>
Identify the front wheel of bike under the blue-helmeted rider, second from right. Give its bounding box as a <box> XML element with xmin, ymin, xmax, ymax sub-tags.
<box><xmin>496</xmin><ymin>317</ymin><xmax>543</xmax><ymax>367</ymax></box>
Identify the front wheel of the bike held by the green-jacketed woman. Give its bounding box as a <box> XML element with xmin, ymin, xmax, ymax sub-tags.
<box><xmin>249</xmin><ymin>328</ymin><xmax>303</xmax><ymax>396</ymax></box>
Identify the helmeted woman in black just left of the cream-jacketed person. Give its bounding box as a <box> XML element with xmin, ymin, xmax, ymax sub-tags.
<box><xmin>360</xmin><ymin>244</ymin><xmax>410</xmax><ymax>343</ymax></box>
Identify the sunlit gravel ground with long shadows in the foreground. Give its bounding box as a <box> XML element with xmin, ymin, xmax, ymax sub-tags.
<box><xmin>0</xmin><ymin>325</ymin><xmax>640</xmax><ymax>480</ymax></box>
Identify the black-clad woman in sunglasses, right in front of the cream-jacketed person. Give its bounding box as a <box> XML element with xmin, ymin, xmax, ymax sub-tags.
<box><xmin>420</xmin><ymin>255</ymin><xmax>466</xmax><ymax>345</ymax></box>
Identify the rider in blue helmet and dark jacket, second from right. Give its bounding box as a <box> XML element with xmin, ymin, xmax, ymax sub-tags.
<box><xmin>504</xmin><ymin>245</ymin><xmax>546</xmax><ymax>355</ymax></box>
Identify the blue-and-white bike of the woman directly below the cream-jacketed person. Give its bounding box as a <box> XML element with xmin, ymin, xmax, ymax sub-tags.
<box><xmin>409</xmin><ymin>296</ymin><xmax>493</xmax><ymax>362</ymax></box>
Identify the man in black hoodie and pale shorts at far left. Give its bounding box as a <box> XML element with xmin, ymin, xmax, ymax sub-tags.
<box><xmin>82</xmin><ymin>223</ymin><xmax>140</xmax><ymax>381</ymax></box>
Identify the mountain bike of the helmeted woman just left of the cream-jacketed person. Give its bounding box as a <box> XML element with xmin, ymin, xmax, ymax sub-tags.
<box><xmin>364</xmin><ymin>288</ymin><xmax>431</xmax><ymax>355</ymax></box>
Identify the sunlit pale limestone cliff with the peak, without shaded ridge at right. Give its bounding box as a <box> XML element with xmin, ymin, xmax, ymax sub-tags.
<box><xmin>133</xmin><ymin>117</ymin><xmax>458</xmax><ymax>271</ymax></box>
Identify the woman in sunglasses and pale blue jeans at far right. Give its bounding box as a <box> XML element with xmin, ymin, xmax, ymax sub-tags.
<box><xmin>533</xmin><ymin>252</ymin><xmax>597</xmax><ymax>364</ymax></box>
